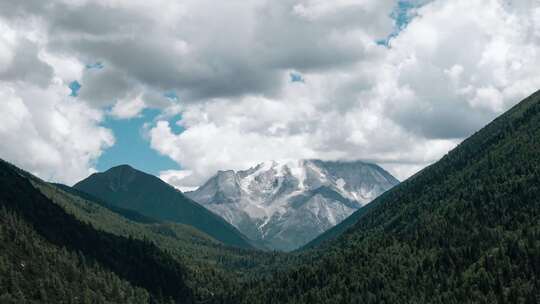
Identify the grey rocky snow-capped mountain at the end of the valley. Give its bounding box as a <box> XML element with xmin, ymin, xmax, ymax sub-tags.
<box><xmin>185</xmin><ymin>160</ymin><xmax>399</xmax><ymax>251</ymax></box>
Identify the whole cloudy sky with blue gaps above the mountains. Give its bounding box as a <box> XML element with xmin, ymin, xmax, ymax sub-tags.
<box><xmin>0</xmin><ymin>0</ymin><xmax>540</xmax><ymax>189</ymax></box>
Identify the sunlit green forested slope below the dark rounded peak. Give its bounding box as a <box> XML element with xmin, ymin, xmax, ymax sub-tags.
<box><xmin>6</xmin><ymin>159</ymin><xmax>295</xmax><ymax>303</ymax></box>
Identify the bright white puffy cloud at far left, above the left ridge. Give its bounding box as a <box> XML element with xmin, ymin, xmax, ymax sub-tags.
<box><xmin>0</xmin><ymin>21</ymin><xmax>114</xmax><ymax>184</ymax></box>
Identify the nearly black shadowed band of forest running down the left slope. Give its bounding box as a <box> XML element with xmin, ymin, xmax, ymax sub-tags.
<box><xmin>0</xmin><ymin>160</ymin><xmax>193</xmax><ymax>303</ymax></box>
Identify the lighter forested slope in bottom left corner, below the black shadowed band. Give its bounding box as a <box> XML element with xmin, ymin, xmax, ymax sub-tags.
<box><xmin>0</xmin><ymin>208</ymin><xmax>149</xmax><ymax>304</ymax></box>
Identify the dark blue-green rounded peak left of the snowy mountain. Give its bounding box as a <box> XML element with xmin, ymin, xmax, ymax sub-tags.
<box><xmin>74</xmin><ymin>165</ymin><xmax>252</xmax><ymax>248</ymax></box>
